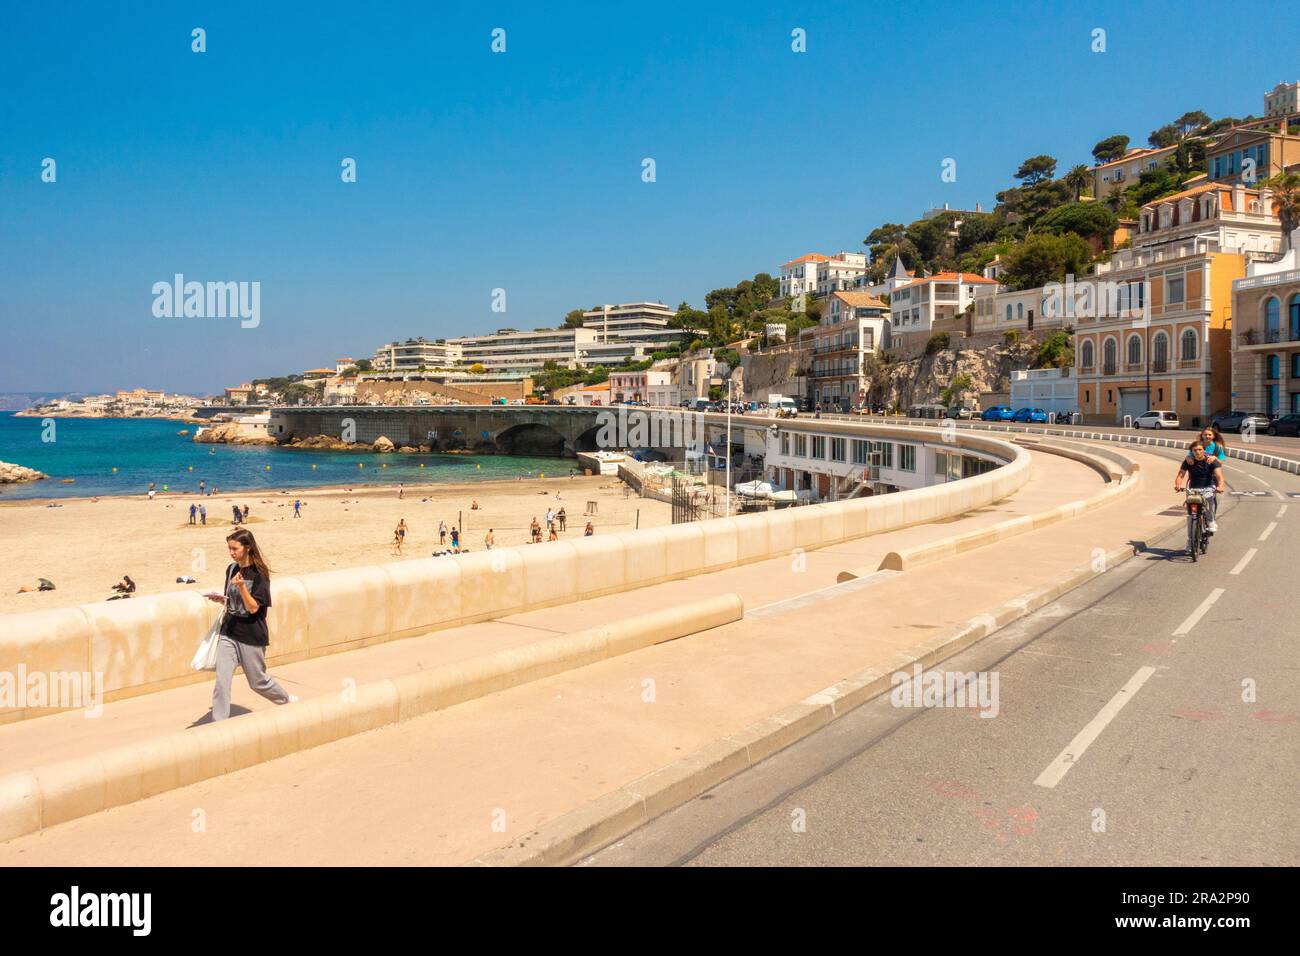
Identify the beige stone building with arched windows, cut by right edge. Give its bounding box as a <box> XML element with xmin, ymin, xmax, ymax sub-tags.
<box><xmin>1232</xmin><ymin>229</ymin><xmax>1300</xmax><ymax>415</ymax></box>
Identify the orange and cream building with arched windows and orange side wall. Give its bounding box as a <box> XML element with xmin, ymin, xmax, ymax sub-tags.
<box><xmin>1075</xmin><ymin>183</ymin><xmax>1281</xmax><ymax>425</ymax></box>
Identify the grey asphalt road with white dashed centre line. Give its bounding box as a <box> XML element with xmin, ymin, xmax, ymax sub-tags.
<box><xmin>582</xmin><ymin>447</ymin><xmax>1300</xmax><ymax>866</ymax></box>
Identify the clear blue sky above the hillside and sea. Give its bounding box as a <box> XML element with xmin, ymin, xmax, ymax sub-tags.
<box><xmin>0</xmin><ymin>0</ymin><xmax>1279</xmax><ymax>392</ymax></box>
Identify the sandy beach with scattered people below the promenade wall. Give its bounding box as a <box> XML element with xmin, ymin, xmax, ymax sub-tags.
<box><xmin>0</xmin><ymin>476</ymin><xmax>672</xmax><ymax>614</ymax></box>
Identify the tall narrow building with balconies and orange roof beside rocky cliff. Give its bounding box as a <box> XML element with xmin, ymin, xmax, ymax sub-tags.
<box><xmin>810</xmin><ymin>291</ymin><xmax>889</xmax><ymax>411</ymax></box>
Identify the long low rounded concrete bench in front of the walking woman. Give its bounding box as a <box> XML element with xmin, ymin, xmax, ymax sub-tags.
<box><xmin>0</xmin><ymin>594</ymin><xmax>745</xmax><ymax>842</ymax></box>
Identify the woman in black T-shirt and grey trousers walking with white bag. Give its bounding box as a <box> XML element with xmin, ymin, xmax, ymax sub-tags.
<box><xmin>207</xmin><ymin>528</ymin><xmax>298</xmax><ymax>721</ymax></box>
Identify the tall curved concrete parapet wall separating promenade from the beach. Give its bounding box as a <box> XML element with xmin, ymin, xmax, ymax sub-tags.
<box><xmin>0</xmin><ymin>419</ymin><xmax>1030</xmax><ymax>721</ymax></box>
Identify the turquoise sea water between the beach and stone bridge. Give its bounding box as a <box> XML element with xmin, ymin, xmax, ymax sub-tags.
<box><xmin>0</xmin><ymin>412</ymin><xmax>575</xmax><ymax>501</ymax></box>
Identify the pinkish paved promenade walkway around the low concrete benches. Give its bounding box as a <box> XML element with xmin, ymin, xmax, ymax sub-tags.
<box><xmin>0</xmin><ymin>447</ymin><xmax>1179</xmax><ymax>865</ymax></box>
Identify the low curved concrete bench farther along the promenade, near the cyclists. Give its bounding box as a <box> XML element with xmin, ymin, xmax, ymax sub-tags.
<box><xmin>836</xmin><ymin>441</ymin><xmax>1141</xmax><ymax>584</ymax></box>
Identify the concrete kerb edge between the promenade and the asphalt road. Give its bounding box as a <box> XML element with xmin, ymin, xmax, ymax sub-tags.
<box><xmin>468</xmin><ymin>519</ymin><xmax>1182</xmax><ymax>866</ymax></box>
